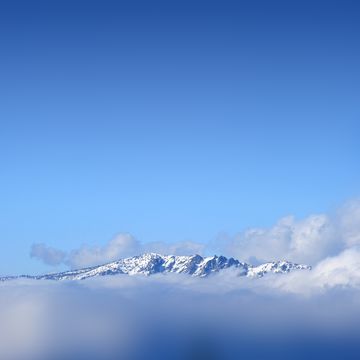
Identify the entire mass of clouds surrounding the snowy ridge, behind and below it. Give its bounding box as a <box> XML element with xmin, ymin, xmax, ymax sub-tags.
<box><xmin>0</xmin><ymin>201</ymin><xmax>360</xmax><ymax>360</ymax></box>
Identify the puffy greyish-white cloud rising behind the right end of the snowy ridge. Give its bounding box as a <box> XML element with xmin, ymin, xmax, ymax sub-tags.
<box><xmin>219</xmin><ymin>201</ymin><xmax>360</xmax><ymax>265</ymax></box>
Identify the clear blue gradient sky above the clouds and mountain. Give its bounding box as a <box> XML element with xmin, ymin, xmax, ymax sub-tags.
<box><xmin>0</xmin><ymin>0</ymin><xmax>360</xmax><ymax>273</ymax></box>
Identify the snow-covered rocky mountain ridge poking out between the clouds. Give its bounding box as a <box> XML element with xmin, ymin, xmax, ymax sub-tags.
<box><xmin>0</xmin><ymin>253</ymin><xmax>311</xmax><ymax>281</ymax></box>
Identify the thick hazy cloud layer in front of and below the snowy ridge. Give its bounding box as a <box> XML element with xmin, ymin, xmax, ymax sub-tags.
<box><xmin>0</xmin><ymin>262</ymin><xmax>360</xmax><ymax>360</ymax></box>
